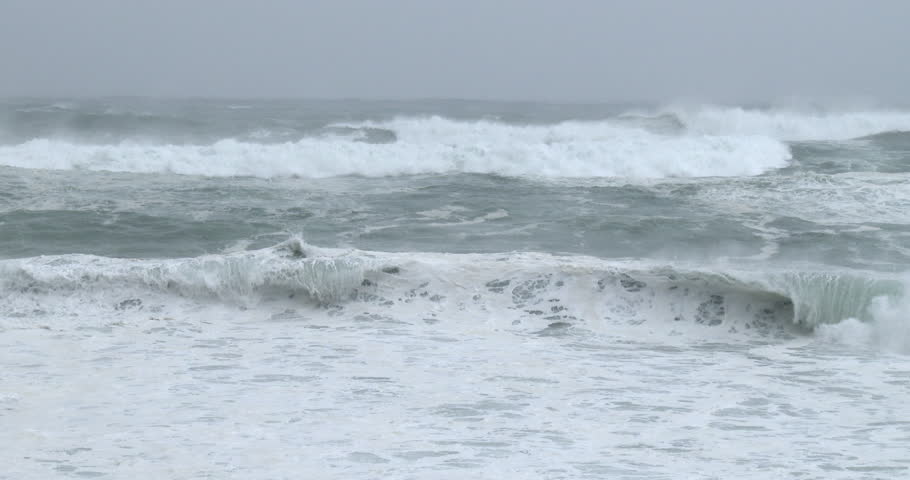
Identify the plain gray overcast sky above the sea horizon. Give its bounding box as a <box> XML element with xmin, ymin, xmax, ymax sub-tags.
<box><xmin>0</xmin><ymin>0</ymin><xmax>910</xmax><ymax>102</ymax></box>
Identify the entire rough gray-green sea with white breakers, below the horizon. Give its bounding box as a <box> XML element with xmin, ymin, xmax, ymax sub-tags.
<box><xmin>0</xmin><ymin>99</ymin><xmax>910</xmax><ymax>479</ymax></box>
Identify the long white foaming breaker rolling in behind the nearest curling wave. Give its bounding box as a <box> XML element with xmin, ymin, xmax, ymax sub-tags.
<box><xmin>0</xmin><ymin>117</ymin><xmax>791</xmax><ymax>178</ymax></box>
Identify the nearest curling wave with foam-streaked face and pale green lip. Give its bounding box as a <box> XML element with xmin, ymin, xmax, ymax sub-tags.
<box><xmin>0</xmin><ymin>239</ymin><xmax>904</xmax><ymax>334</ymax></box>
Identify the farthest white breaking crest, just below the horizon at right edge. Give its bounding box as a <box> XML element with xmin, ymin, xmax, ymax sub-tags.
<box><xmin>661</xmin><ymin>106</ymin><xmax>910</xmax><ymax>140</ymax></box>
